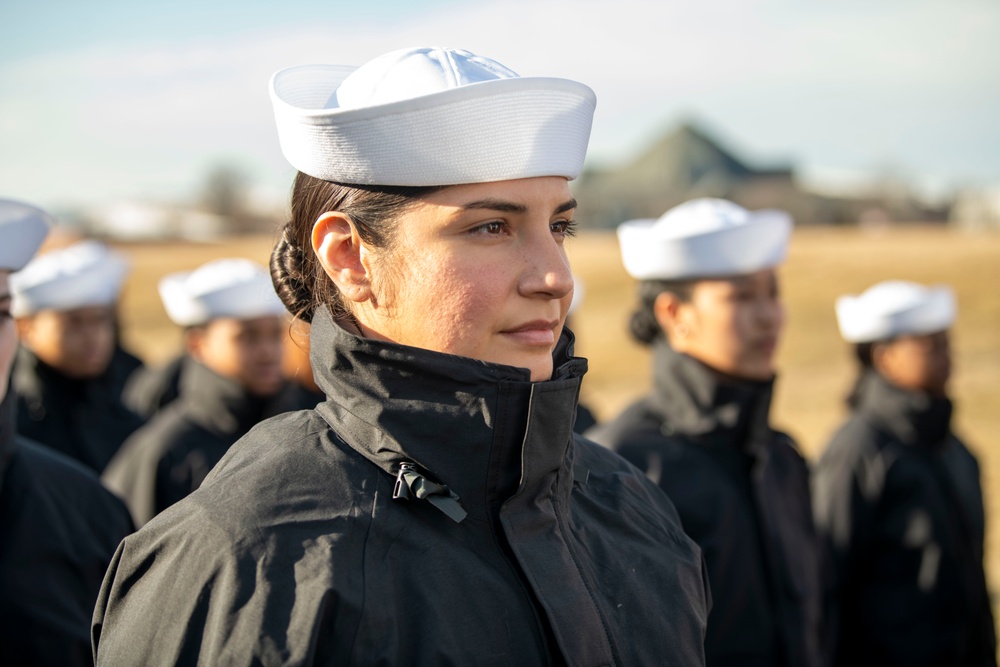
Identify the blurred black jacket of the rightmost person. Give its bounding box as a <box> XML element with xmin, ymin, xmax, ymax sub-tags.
<box><xmin>815</xmin><ymin>372</ymin><xmax>996</xmax><ymax>667</ymax></box>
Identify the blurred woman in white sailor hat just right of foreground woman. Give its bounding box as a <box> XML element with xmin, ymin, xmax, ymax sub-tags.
<box><xmin>586</xmin><ymin>199</ymin><xmax>823</xmax><ymax>667</ymax></box>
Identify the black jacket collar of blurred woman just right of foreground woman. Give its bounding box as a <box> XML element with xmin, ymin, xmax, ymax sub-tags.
<box><xmin>651</xmin><ymin>341</ymin><xmax>774</xmax><ymax>447</ymax></box>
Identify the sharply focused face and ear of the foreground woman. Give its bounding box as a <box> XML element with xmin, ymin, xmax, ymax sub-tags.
<box><xmin>313</xmin><ymin>177</ymin><xmax>576</xmax><ymax>381</ymax></box>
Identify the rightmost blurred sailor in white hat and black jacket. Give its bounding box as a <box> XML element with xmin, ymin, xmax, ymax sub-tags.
<box><xmin>814</xmin><ymin>280</ymin><xmax>996</xmax><ymax>666</ymax></box>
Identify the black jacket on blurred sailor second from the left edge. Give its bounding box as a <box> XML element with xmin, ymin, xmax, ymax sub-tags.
<box><xmin>11</xmin><ymin>346</ymin><xmax>144</xmax><ymax>474</ymax></box>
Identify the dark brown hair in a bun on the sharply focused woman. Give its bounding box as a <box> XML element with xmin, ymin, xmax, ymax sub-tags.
<box><xmin>271</xmin><ymin>172</ymin><xmax>441</xmax><ymax>322</ymax></box>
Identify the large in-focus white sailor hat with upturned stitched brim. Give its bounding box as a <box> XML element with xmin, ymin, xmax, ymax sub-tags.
<box><xmin>270</xmin><ymin>47</ymin><xmax>597</xmax><ymax>186</ymax></box>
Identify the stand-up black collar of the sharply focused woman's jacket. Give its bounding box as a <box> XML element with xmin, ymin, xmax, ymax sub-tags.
<box><xmin>310</xmin><ymin>308</ymin><xmax>587</xmax><ymax>518</ymax></box>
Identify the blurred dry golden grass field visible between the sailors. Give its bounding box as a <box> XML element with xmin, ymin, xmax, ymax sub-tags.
<box><xmin>109</xmin><ymin>227</ymin><xmax>1000</xmax><ymax>591</ymax></box>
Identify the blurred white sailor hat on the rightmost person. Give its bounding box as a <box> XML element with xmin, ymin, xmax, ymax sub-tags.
<box><xmin>837</xmin><ymin>280</ymin><xmax>957</xmax><ymax>343</ymax></box>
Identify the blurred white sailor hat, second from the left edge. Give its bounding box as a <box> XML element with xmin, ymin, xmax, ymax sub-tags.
<box><xmin>10</xmin><ymin>241</ymin><xmax>128</xmax><ymax>317</ymax></box>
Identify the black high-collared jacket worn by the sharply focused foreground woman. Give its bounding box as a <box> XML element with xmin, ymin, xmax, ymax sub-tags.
<box><xmin>94</xmin><ymin>311</ymin><xmax>708</xmax><ymax>667</ymax></box>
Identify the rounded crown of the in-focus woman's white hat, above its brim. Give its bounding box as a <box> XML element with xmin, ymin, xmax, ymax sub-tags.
<box><xmin>340</xmin><ymin>47</ymin><xmax>517</xmax><ymax>109</ymax></box>
